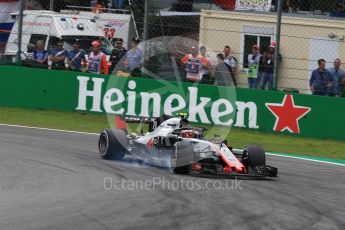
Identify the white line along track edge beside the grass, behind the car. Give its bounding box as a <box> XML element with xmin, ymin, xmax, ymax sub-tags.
<box><xmin>0</xmin><ymin>124</ymin><xmax>345</xmax><ymax>167</ymax></box>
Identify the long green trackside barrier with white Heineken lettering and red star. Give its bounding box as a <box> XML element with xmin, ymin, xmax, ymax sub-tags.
<box><xmin>0</xmin><ymin>66</ymin><xmax>345</xmax><ymax>140</ymax></box>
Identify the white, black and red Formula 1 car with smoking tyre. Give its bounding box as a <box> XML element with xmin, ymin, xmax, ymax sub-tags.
<box><xmin>98</xmin><ymin>116</ymin><xmax>278</xmax><ymax>177</ymax></box>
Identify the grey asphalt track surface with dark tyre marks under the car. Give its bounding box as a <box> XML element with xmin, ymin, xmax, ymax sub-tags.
<box><xmin>0</xmin><ymin>126</ymin><xmax>345</xmax><ymax>230</ymax></box>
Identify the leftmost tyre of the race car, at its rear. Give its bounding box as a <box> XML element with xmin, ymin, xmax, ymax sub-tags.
<box><xmin>98</xmin><ymin>129</ymin><xmax>128</xmax><ymax>161</ymax></box>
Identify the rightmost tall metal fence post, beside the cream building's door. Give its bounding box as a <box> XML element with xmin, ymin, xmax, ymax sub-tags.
<box><xmin>273</xmin><ymin>0</ymin><xmax>283</xmax><ymax>90</ymax></box>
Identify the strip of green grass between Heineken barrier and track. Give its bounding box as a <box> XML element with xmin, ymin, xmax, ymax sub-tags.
<box><xmin>0</xmin><ymin>107</ymin><xmax>345</xmax><ymax>159</ymax></box>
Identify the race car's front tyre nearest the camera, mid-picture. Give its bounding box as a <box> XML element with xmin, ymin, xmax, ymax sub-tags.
<box><xmin>171</xmin><ymin>142</ymin><xmax>194</xmax><ymax>174</ymax></box>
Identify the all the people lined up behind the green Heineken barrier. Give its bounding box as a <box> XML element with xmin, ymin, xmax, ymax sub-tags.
<box><xmin>18</xmin><ymin>35</ymin><xmax>345</xmax><ymax>97</ymax></box>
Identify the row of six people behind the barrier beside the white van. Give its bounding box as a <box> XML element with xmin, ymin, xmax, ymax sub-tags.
<box><xmin>22</xmin><ymin>38</ymin><xmax>142</xmax><ymax>76</ymax></box>
